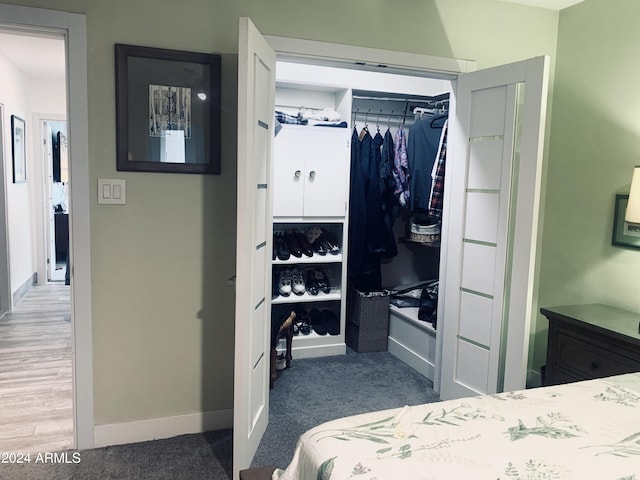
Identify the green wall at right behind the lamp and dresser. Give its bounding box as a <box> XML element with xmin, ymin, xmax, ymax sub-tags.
<box><xmin>532</xmin><ymin>0</ymin><xmax>640</xmax><ymax>376</ymax></box>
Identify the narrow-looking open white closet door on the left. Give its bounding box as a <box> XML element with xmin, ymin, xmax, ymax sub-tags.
<box><xmin>233</xmin><ymin>18</ymin><xmax>276</xmax><ymax>479</ymax></box>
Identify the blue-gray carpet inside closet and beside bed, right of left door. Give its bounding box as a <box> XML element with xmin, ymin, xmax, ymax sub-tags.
<box><xmin>252</xmin><ymin>351</ymin><xmax>439</xmax><ymax>468</ymax></box>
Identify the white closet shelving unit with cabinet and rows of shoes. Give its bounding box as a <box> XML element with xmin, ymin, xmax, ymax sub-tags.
<box><xmin>271</xmin><ymin>110</ymin><xmax>351</xmax><ymax>362</ymax></box>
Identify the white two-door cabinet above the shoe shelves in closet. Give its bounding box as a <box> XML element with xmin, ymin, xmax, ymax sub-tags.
<box><xmin>273</xmin><ymin>125</ymin><xmax>350</xmax><ymax>217</ymax></box>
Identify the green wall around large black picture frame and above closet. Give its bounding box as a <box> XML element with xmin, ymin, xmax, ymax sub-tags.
<box><xmin>0</xmin><ymin>0</ymin><xmax>558</xmax><ymax>425</ymax></box>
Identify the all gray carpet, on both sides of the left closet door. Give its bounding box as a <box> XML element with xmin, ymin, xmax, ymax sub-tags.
<box><xmin>0</xmin><ymin>352</ymin><xmax>438</xmax><ymax>480</ymax></box>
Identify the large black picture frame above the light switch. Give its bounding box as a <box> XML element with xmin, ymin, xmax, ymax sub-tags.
<box><xmin>115</xmin><ymin>44</ymin><xmax>221</xmax><ymax>174</ymax></box>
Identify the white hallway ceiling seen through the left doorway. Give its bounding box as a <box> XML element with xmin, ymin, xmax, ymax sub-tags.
<box><xmin>0</xmin><ymin>31</ymin><xmax>66</xmax><ymax>82</ymax></box>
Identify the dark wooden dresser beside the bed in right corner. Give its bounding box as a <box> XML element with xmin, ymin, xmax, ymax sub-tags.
<box><xmin>540</xmin><ymin>304</ymin><xmax>640</xmax><ymax>385</ymax></box>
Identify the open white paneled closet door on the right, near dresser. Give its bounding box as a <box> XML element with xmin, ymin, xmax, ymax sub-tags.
<box><xmin>438</xmin><ymin>57</ymin><xmax>548</xmax><ymax>400</ymax></box>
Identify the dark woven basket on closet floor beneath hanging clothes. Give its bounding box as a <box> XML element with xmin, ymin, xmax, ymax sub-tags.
<box><xmin>346</xmin><ymin>290</ymin><xmax>391</xmax><ymax>353</ymax></box>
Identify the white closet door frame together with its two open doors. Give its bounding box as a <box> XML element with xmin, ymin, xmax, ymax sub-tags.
<box><xmin>234</xmin><ymin>19</ymin><xmax>548</xmax><ymax>473</ymax></box>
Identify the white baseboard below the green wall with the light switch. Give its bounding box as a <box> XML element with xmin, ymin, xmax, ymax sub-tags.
<box><xmin>93</xmin><ymin>409</ymin><xmax>233</xmax><ymax>447</ymax></box>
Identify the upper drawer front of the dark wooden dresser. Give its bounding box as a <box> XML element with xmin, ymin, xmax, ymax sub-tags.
<box><xmin>554</xmin><ymin>329</ymin><xmax>639</xmax><ymax>379</ymax></box>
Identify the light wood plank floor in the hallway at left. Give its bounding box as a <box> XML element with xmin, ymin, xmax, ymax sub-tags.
<box><xmin>0</xmin><ymin>282</ymin><xmax>73</xmax><ymax>453</ymax></box>
